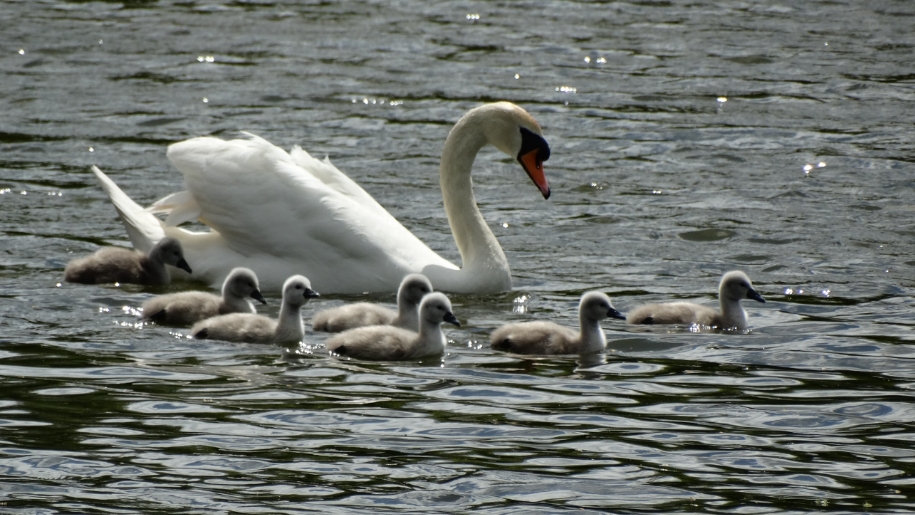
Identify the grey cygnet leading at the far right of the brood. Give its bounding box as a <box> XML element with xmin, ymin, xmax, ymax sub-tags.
<box><xmin>626</xmin><ymin>270</ymin><xmax>766</xmax><ymax>331</ymax></box>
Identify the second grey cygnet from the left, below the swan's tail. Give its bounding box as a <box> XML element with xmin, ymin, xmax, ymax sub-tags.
<box><xmin>142</xmin><ymin>267</ymin><xmax>267</xmax><ymax>326</ymax></box>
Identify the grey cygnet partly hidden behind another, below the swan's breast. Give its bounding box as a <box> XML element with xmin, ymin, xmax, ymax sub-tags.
<box><xmin>311</xmin><ymin>274</ymin><xmax>432</xmax><ymax>333</ymax></box>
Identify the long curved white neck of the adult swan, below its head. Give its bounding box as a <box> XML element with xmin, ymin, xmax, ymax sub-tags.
<box><xmin>433</xmin><ymin>116</ymin><xmax>511</xmax><ymax>291</ymax></box>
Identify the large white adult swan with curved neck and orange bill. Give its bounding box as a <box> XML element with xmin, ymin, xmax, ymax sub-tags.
<box><xmin>93</xmin><ymin>102</ymin><xmax>550</xmax><ymax>293</ymax></box>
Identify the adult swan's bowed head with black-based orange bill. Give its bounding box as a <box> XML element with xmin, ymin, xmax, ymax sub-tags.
<box><xmin>468</xmin><ymin>102</ymin><xmax>550</xmax><ymax>198</ymax></box>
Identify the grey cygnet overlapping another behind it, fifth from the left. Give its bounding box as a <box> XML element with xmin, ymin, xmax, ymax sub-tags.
<box><xmin>325</xmin><ymin>293</ymin><xmax>461</xmax><ymax>361</ymax></box>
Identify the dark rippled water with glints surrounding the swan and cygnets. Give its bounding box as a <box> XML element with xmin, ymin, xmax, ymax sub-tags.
<box><xmin>0</xmin><ymin>0</ymin><xmax>915</xmax><ymax>514</ymax></box>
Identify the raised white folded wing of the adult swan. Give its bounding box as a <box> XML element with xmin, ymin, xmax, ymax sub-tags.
<box><xmin>168</xmin><ymin>136</ymin><xmax>454</xmax><ymax>292</ymax></box>
